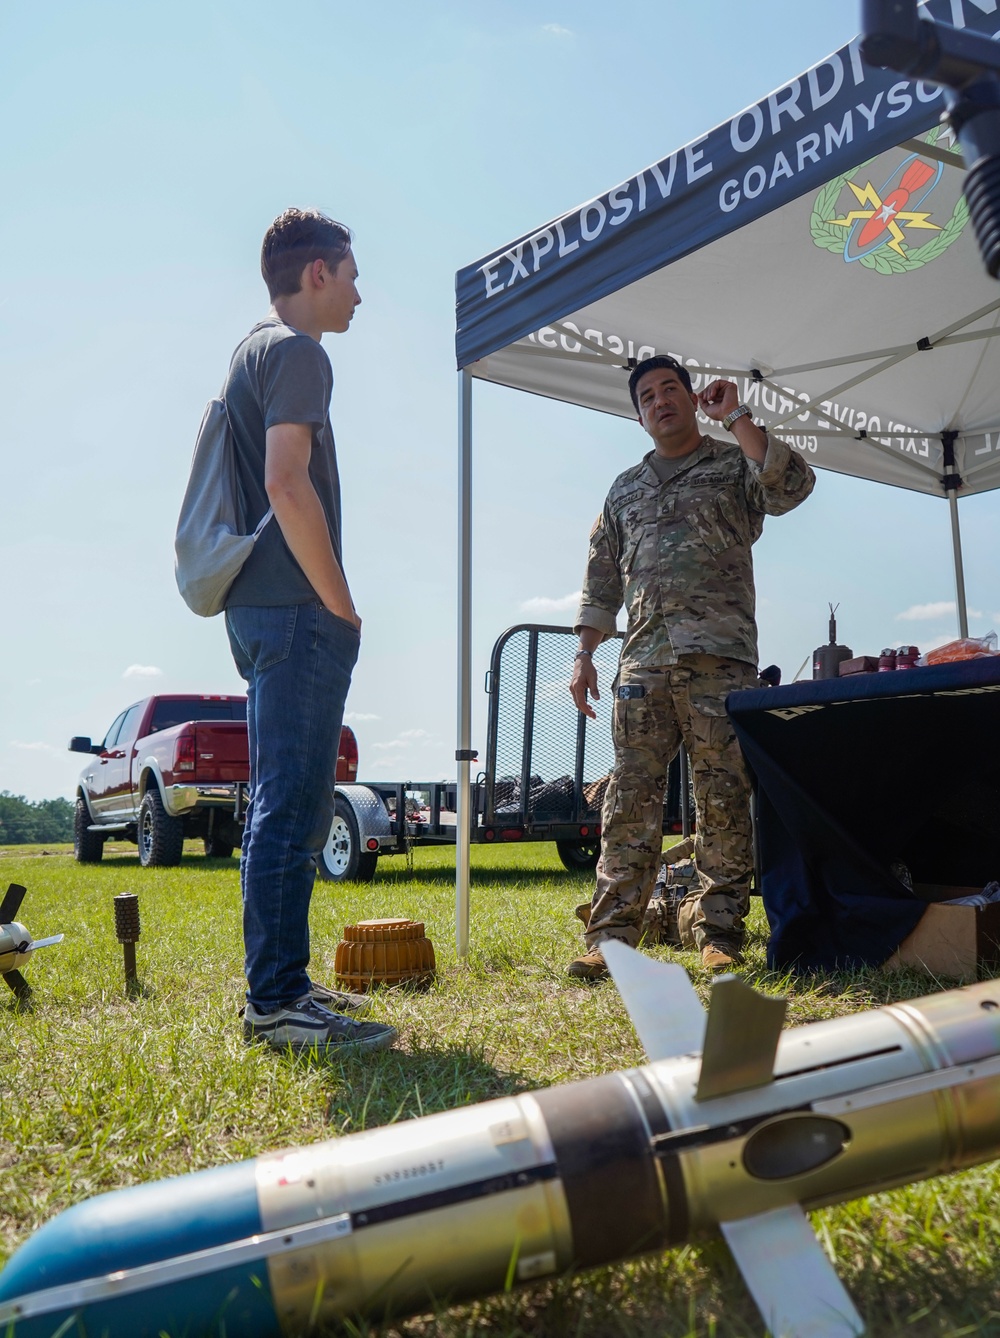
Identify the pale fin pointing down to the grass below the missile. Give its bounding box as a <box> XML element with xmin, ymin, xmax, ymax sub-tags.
<box><xmin>720</xmin><ymin>1203</ymin><xmax>865</xmax><ymax>1338</ymax></box>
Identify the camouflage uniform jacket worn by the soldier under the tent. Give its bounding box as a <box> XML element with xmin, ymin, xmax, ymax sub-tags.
<box><xmin>576</xmin><ymin>436</ymin><xmax>815</xmax><ymax>669</ymax></box>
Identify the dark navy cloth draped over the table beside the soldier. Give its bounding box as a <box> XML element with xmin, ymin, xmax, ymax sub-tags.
<box><xmin>727</xmin><ymin>656</ymin><xmax>1000</xmax><ymax>970</ymax></box>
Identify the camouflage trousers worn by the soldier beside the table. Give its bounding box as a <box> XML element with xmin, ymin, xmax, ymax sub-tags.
<box><xmin>586</xmin><ymin>654</ymin><xmax>758</xmax><ymax>949</ymax></box>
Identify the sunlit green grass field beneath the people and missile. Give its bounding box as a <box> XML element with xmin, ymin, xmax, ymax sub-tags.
<box><xmin>0</xmin><ymin>846</ymin><xmax>1000</xmax><ymax>1338</ymax></box>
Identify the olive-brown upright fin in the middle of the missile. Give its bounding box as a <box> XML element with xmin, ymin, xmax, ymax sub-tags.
<box><xmin>695</xmin><ymin>975</ymin><xmax>788</xmax><ymax>1101</ymax></box>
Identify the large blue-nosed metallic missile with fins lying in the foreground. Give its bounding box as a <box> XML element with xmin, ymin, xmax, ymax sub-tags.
<box><xmin>0</xmin><ymin>943</ymin><xmax>1000</xmax><ymax>1338</ymax></box>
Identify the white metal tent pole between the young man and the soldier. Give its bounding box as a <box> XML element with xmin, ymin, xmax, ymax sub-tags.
<box><xmin>455</xmin><ymin>371</ymin><xmax>473</xmax><ymax>962</ymax></box>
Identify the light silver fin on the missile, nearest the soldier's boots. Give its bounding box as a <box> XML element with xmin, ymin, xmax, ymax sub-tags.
<box><xmin>601</xmin><ymin>939</ymin><xmax>705</xmax><ymax>1060</ymax></box>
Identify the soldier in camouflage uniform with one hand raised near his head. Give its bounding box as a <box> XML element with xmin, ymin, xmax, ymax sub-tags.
<box><xmin>569</xmin><ymin>357</ymin><xmax>815</xmax><ymax>979</ymax></box>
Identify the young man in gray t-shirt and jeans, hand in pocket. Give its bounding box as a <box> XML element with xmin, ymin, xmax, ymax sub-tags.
<box><xmin>225</xmin><ymin>209</ymin><xmax>396</xmax><ymax>1052</ymax></box>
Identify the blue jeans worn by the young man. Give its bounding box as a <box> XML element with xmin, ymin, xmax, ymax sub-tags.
<box><xmin>226</xmin><ymin>603</ymin><xmax>360</xmax><ymax>1013</ymax></box>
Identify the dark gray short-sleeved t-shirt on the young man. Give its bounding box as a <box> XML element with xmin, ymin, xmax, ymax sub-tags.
<box><xmin>222</xmin><ymin>316</ymin><xmax>343</xmax><ymax>606</ymax></box>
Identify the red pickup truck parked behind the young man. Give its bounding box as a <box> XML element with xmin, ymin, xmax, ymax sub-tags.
<box><xmin>70</xmin><ymin>694</ymin><xmax>357</xmax><ymax>867</ymax></box>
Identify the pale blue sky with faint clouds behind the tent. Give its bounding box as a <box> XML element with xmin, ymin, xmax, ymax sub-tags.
<box><xmin>0</xmin><ymin>0</ymin><xmax>1000</xmax><ymax>799</ymax></box>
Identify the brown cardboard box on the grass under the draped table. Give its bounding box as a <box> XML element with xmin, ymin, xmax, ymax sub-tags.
<box><xmin>882</xmin><ymin>884</ymin><xmax>1000</xmax><ymax>981</ymax></box>
